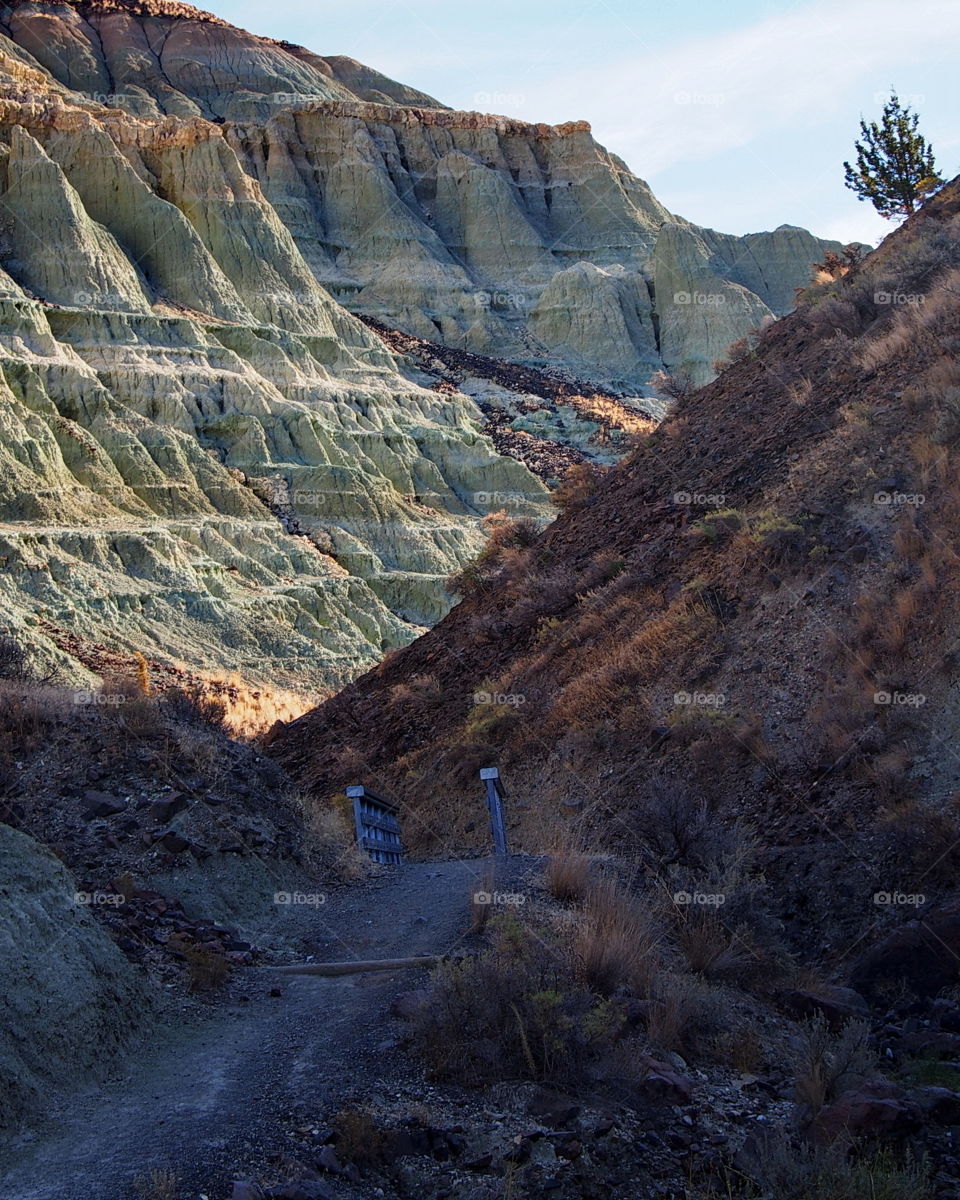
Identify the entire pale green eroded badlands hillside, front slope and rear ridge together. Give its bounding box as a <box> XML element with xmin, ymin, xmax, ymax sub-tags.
<box><xmin>0</xmin><ymin>0</ymin><xmax>828</xmax><ymax>689</ymax></box>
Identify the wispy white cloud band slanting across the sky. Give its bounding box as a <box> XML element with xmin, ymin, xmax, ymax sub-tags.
<box><xmin>526</xmin><ymin>0</ymin><xmax>960</xmax><ymax>176</ymax></box>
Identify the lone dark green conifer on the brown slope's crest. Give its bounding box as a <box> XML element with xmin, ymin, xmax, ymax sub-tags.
<box><xmin>844</xmin><ymin>90</ymin><xmax>943</xmax><ymax>220</ymax></box>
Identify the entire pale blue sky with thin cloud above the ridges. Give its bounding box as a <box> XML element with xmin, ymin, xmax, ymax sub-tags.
<box><xmin>217</xmin><ymin>0</ymin><xmax>960</xmax><ymax>241</ymax></box>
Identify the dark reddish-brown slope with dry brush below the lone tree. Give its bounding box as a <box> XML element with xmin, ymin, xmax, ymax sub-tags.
<box><xmin>275</xmin><ymin>182</ymin><xmax>960</xmax><ymax>959</ymax></box>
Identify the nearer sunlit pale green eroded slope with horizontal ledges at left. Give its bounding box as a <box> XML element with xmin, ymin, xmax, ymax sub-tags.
<box><xmin>0</xmin><ymin>28</ymin><xmax>546</xmax><ymax>689</ymax></box>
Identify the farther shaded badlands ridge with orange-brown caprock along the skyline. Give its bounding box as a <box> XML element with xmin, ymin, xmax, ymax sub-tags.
<box><xmin>5</xmin><ymin>0</ymin><xmax>839</xmax><ymax>392</ymax></box>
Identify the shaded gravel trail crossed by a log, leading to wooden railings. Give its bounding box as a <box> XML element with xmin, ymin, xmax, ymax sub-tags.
<box><xmin>0</xmin><ymin>859</ymin><xmax>518</xmax><ymax>1200</ymax></box>
